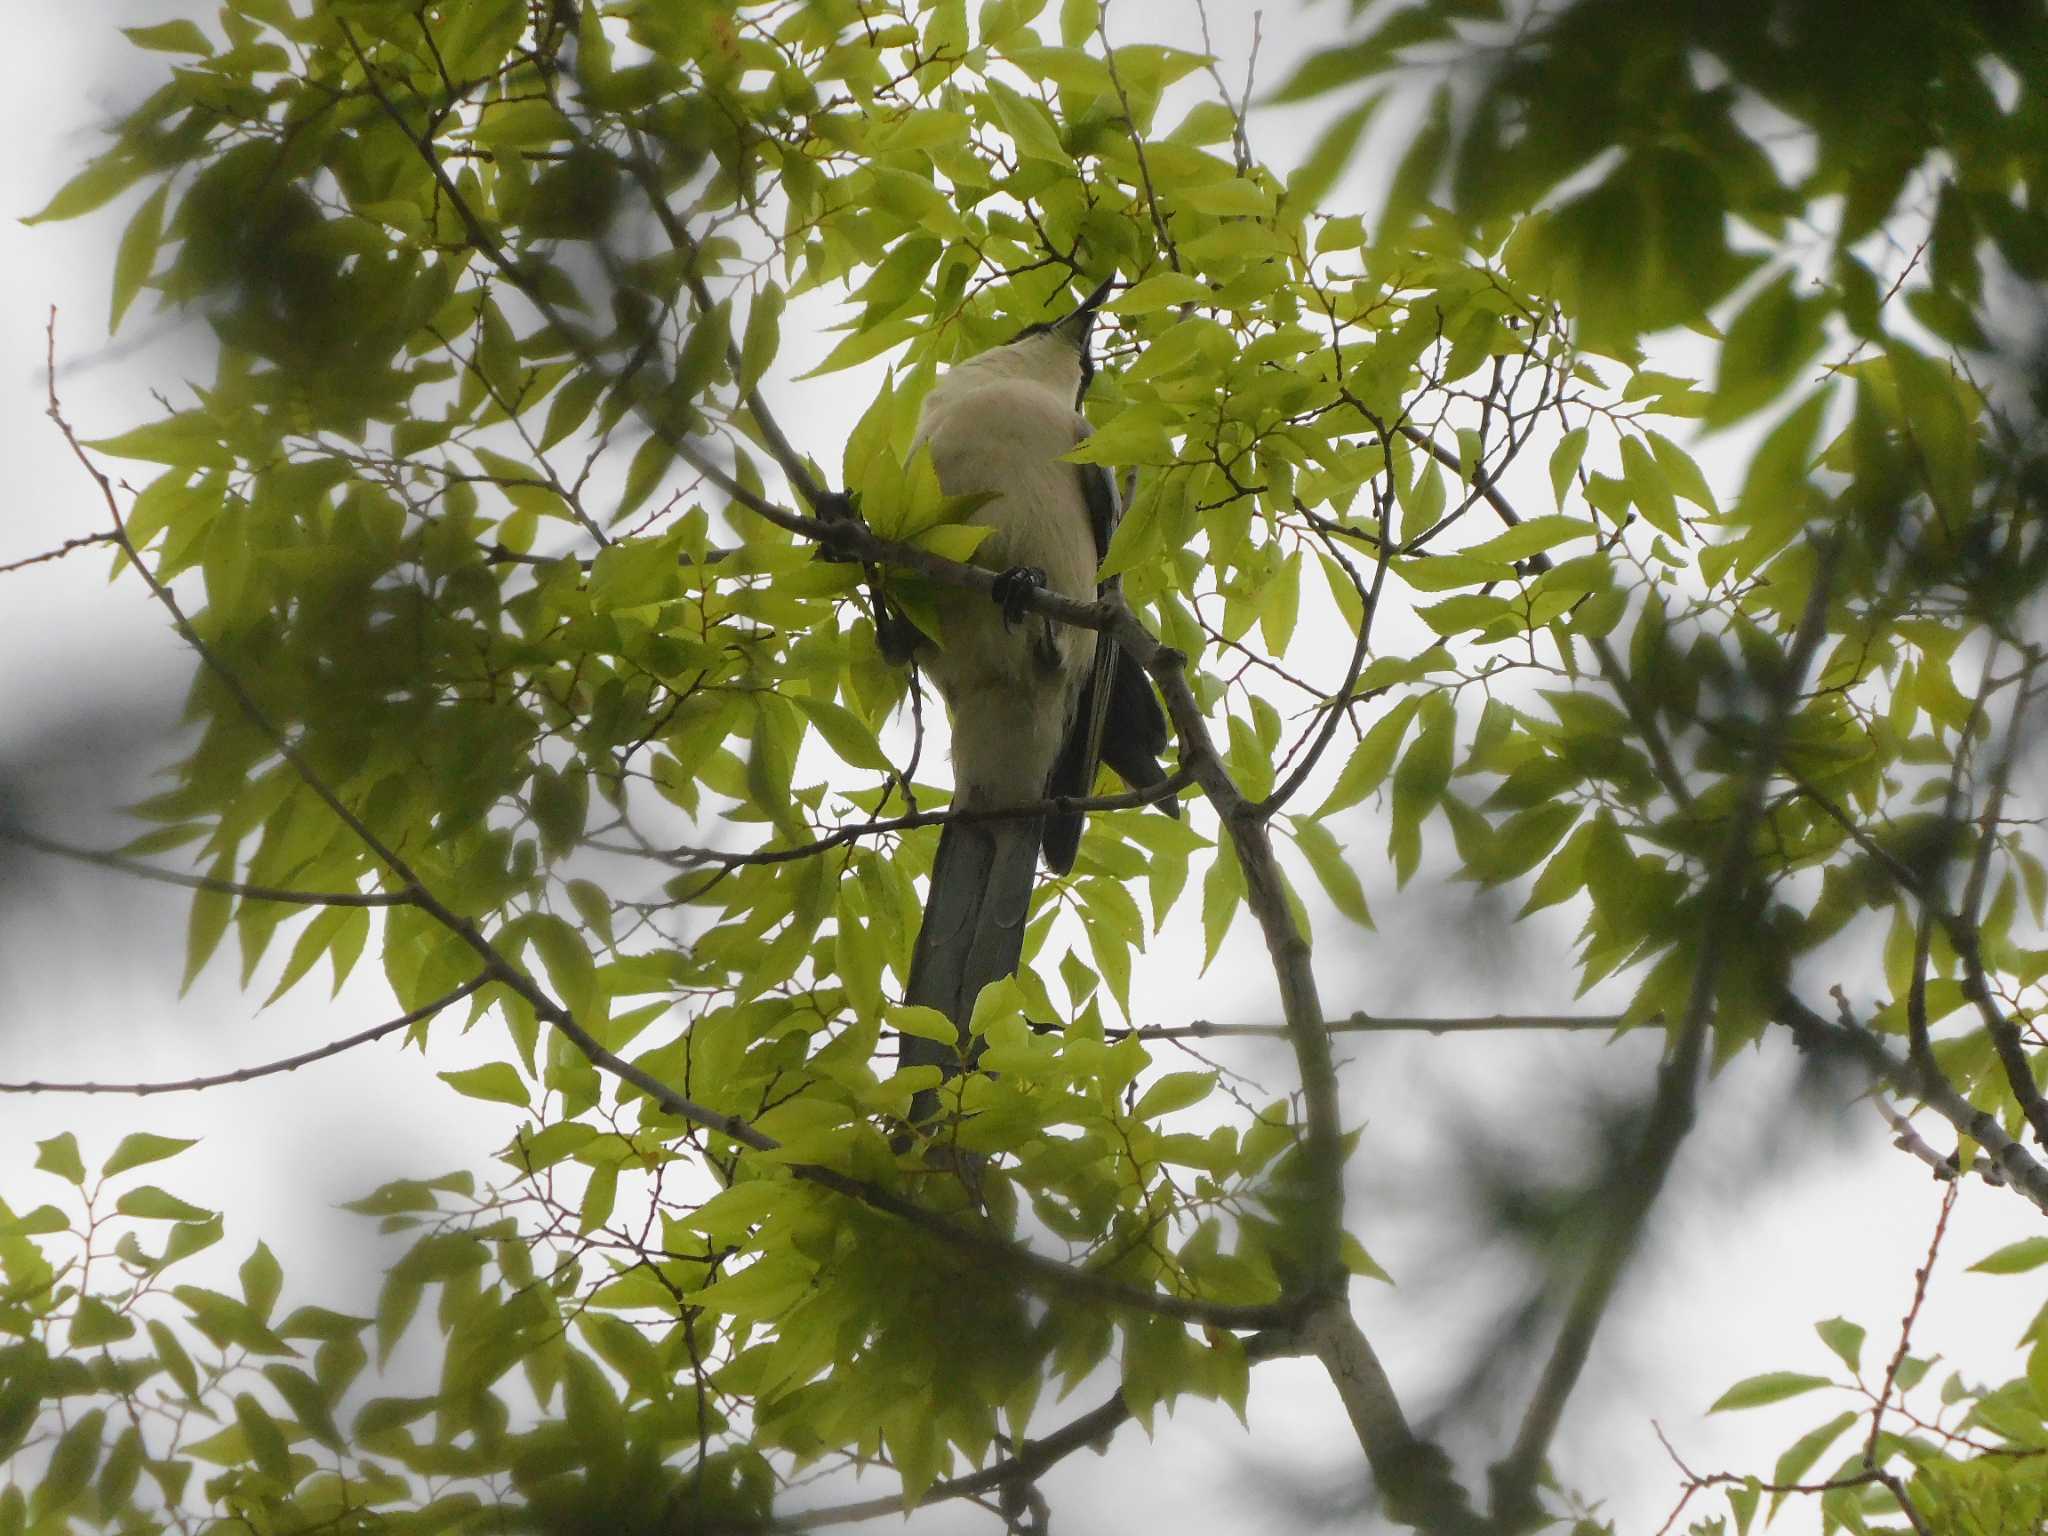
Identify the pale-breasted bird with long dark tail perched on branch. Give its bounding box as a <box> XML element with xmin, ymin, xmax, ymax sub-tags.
<box><xmin>885</xmin><ymin>279</ymin><xmax>1180</xmax><ymax>1122</ymax></box>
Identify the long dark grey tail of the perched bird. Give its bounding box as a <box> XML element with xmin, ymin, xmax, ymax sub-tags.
<box><xmin>899</xmin><ymin>817</ymin><xmax>1040</xmax><ymax>1122</ymax></box>
